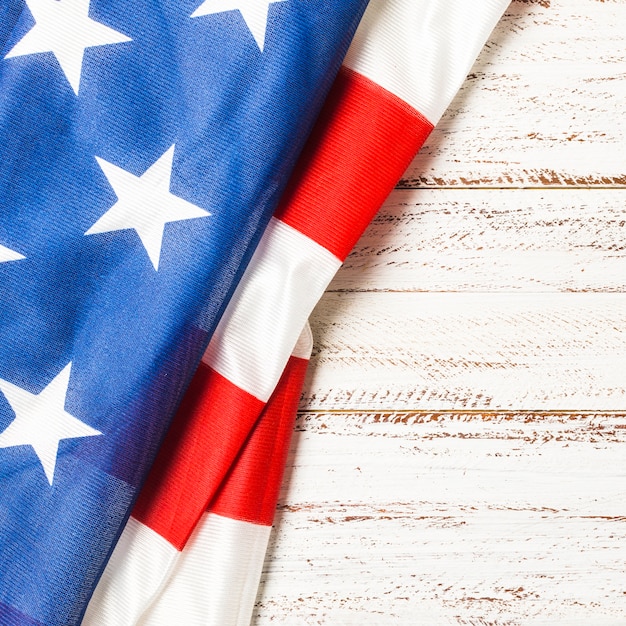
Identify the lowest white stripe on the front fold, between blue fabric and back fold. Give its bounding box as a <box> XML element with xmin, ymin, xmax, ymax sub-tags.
<box><xmin>82</xmin><ymin>517</ymin><xmax>180</xmax><ymax>626</ymax></box>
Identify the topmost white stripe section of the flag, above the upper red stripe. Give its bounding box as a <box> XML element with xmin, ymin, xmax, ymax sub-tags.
<box><xmin>344</xmin><ymin>0</ymin><xmax>509</xmax><ymax>124</ymax></box>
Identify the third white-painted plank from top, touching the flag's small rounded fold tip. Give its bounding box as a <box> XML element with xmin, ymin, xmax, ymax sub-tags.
<box><xmin>302</xmin><ymin>293</ymin><xmax>626</xmax><ymax>410</ymax></box>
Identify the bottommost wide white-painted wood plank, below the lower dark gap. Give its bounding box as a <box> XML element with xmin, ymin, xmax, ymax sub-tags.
<box><xmin>253</xmin><ymin>413</ymin><xmax>626</xmax><ymax>626</ymax></box>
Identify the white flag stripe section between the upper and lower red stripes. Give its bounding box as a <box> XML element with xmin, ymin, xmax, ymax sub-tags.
<box><xmin>202</xmin><ymin>218</ymin><xmax>341</xmax><ymax>402</ymax></box>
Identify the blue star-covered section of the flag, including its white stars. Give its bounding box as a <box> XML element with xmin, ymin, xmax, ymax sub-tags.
<box><xmin>0</xmin><ymin>0</ymin><xmax>367</xmax><ymax>626</ymax></box>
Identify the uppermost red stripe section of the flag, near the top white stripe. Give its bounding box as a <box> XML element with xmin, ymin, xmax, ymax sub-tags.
<box><xmin>275</xmin><ymin>67</ymin><xmax>433</xmax><ymax>261</ymax></box>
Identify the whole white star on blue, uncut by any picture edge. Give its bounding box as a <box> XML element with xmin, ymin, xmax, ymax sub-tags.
<box><xmin>85</xmin><ymin>146</ymin><xmax>211</xmax><ymax>270</ymax></box>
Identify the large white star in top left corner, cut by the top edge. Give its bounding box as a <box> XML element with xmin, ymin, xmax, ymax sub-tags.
<box><xmin>5</xmin><ymin>0</ymin><xmax>132</xmax><ymax>95</ymax></box>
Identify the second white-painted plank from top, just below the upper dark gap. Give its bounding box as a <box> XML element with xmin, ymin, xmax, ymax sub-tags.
<box><xmin>330</xmin><ymin>188</ymin><xmax>626</xmax><ymax>292</ymax></box>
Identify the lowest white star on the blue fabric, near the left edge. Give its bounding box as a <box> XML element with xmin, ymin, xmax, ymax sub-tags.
<box><xmin>0</xmin><ymin>363</ymin><xmax>102</xmax><ymax>485</ymax></box>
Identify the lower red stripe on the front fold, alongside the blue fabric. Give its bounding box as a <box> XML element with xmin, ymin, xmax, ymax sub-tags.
<box><xmin>133</xmin><ymin>363</ymin><xmax>265</xmax><ymax>550</ymax></box>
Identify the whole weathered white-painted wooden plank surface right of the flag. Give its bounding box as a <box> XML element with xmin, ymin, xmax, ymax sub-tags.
<box><xmin>253</xmin><ymin>0</ymin><xmax>626</xmax><ymax>626</ymax></box>
